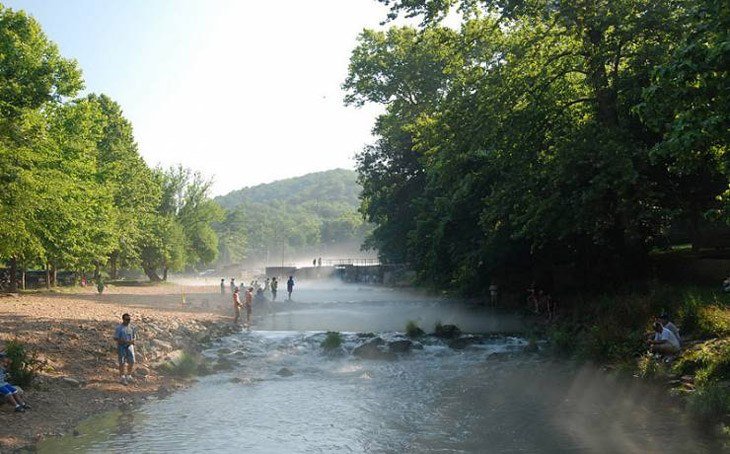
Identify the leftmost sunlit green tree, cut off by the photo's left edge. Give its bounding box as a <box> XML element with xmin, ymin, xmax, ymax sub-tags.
<box><xmin>0</xmin><ymin>5</ymin><xmax>82</xmax><ymax>290</ymax></box>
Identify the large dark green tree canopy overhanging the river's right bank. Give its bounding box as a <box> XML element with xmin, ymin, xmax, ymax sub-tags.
<box><xmin>343</xmin><ymin>0</ymin><xmax>730</xmax><ymax>294</ymax></box>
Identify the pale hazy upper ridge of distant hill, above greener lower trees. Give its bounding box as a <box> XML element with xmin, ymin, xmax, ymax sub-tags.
<box><xmin>215</xmin><ymin>169</ymin><xmax>361</xmax><ymax>210</ymax></box>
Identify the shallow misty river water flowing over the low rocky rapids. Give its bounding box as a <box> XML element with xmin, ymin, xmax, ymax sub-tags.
<box><xmin>38</xmin><ymin>284</ymin><xmax>718</xmax><ymax>453</ymax></box>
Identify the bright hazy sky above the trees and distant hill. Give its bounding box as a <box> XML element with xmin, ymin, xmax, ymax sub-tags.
<box><xmin>7</xmin><ymin>0</ymin><xmax>386</xmax><ymax>195</ymax></box>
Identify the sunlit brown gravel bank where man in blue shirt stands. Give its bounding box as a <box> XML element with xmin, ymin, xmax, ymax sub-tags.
<box><xmin>0</xmin><ymin>285</ymin><xmax>230</xmax><ymax>453</ymax></box>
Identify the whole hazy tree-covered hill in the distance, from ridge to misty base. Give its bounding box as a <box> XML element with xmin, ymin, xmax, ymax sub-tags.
<box><xmin>215</xmin><ymin>169</ymin><xmax>370</xmax><ymax>265</ymax></box>
